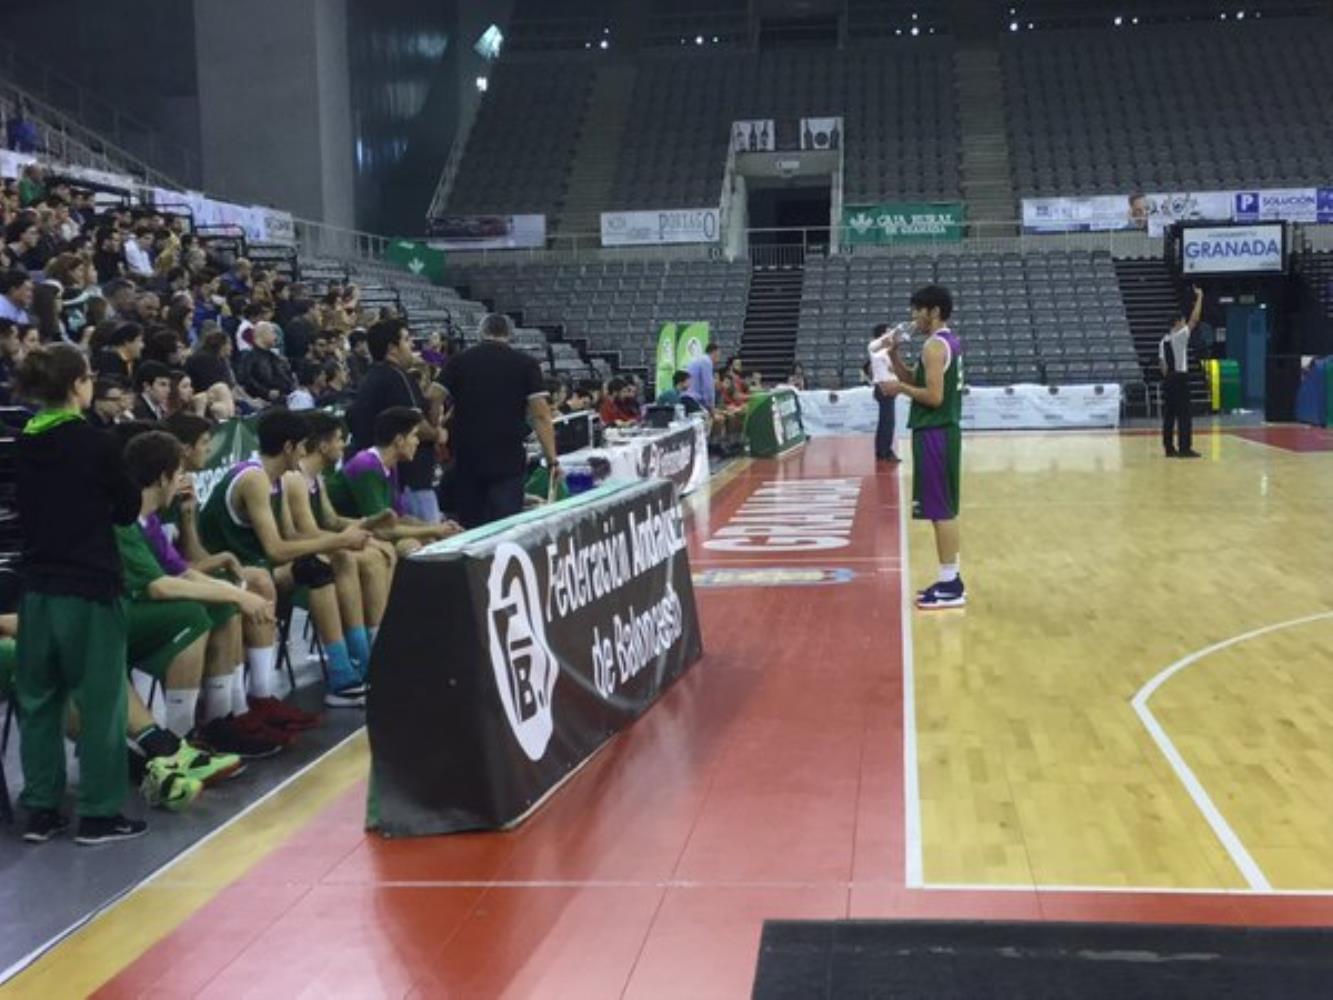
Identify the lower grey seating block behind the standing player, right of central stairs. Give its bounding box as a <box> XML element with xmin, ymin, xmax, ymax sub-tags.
<box><xmin>797</xmin><ymin>251</ymin><xmax>1142</xmax><ymax>388</ymax></box>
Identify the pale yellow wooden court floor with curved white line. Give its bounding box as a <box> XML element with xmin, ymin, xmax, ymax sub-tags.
<box><xmin>912</xmin><ymin>424</ymin><xmax>1333</xmax><ymax>891</ymax></box>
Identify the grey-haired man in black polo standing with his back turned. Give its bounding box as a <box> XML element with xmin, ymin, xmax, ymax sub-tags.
<box><xmin>444</xmin><ymin>313</ymin><xmax>560</xmax><ymax>528</ymax></box>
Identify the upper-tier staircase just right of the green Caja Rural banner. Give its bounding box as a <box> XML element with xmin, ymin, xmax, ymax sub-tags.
<box><xmin>953</xmin><ymin>41</ymin><xmax>1018</xmax><ymax>236</ymax></box>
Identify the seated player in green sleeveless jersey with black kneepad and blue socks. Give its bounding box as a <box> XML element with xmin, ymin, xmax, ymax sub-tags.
<box><xmin>199</xmin><ymin>407</ymin><xmax>371</xmax><ymax>708</ymax></box>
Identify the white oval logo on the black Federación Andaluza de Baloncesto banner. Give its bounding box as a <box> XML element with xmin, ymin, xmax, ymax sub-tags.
<box><xmin>487</xmin><ymin>541</ymin><xmax>560</xmax><ymax>761</ymax></box>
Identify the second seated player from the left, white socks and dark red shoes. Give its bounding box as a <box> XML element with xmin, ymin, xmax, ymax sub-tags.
<box><xmin>159</xmin><ymin>413</ymin><xmax>319</xmax><ymax>732</ymax></box>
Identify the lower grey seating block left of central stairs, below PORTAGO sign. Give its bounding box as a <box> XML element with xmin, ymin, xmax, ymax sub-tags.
<box><xmin>453</xmin><ymin>260</ymin><xmax>750</xmax><ymax>371</ymax></box>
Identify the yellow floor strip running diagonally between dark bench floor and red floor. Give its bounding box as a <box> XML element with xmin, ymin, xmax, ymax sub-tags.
<box><xmin>0</xmin><ymin>729</ymin><xmax>369</xmax><ymax>999</ymax></box>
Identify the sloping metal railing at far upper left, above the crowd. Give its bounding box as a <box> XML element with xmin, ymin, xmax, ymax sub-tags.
<box><xmin>0</xmin><ymin>40</ymin><xmax>203</xmax><ymax>187</ymax></box>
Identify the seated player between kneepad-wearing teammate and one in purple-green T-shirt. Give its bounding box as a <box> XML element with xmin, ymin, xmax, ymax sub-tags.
<box><xmin>280</xmin><ymin>411</ymin><xmax>397</xmax><ymax>659</ymax></box>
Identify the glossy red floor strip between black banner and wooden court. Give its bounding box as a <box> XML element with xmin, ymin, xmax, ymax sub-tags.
<box><xmin>91</xmin><ymin>440</ymin><xmax>1333</xmax><ymax>1000</ymax></box>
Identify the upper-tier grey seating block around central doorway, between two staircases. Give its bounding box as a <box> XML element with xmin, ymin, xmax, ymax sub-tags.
<box><xmin>612</xmin><ymin>39</ymin><xmax>960</xmax><ymax>208</ymax></box>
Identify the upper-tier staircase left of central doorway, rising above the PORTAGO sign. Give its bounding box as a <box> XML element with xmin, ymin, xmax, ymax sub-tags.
<box><xmin>553</xmin><ymin>63</ymin><xmax>639</xmax><ymax>236</ymax></box>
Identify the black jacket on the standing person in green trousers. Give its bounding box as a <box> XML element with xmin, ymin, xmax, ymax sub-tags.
<box><xmin>15</xmin><ymin>420</ymin><xmax>140</xmax><ymax>600</ymax></box>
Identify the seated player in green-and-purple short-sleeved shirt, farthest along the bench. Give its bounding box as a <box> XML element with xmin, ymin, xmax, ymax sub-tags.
<box><xmin>325</xmin><ymin>407</ymin><xmax>463</xmax><ymax>556</ymax></box>
